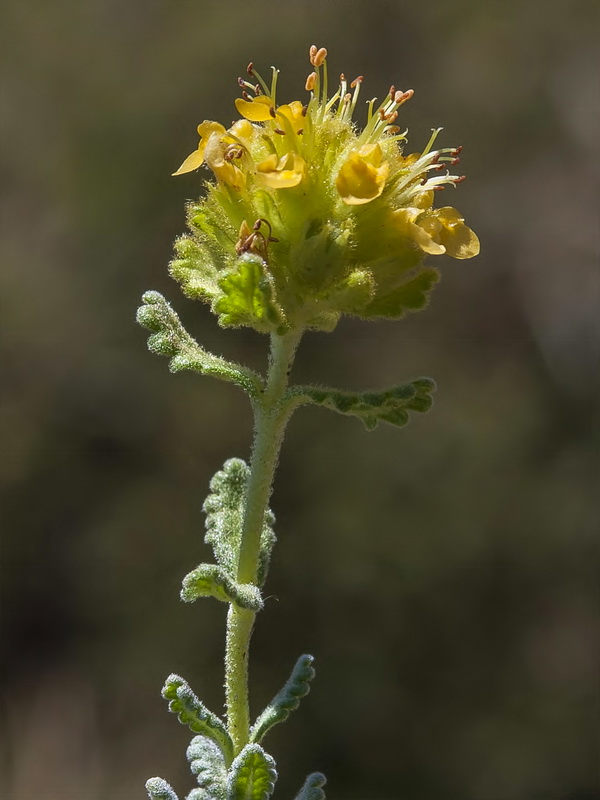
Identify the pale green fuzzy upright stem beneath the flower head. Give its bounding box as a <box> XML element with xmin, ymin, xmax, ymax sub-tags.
<box><xmin>225</xmin><ymin>331</ymin><xmax>302</xmax><ymax>753</ymax></box>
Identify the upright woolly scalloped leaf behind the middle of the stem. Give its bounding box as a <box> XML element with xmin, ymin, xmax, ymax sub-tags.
<box><xmin>203</xmin><ymin>458</ymin><xmax>276</xmax><ymax>586</ymax></box>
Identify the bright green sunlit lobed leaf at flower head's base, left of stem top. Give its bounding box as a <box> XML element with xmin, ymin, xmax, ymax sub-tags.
<box><xmin>213</xmin><ymin>253</ymin><xmax>286</xmax><ymax>333</ymax></box>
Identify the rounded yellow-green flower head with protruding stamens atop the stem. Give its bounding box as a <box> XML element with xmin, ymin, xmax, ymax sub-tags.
<box><xmin>171</xmin><ymin>45</ymin><xmax>479</xmax><ymax>333</ymax></box>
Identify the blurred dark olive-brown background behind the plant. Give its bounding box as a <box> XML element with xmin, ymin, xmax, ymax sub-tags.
<box><xmin>1</xmin><ymin>0</ymin><xmax>600</xmax><ymax>800</ymax></box>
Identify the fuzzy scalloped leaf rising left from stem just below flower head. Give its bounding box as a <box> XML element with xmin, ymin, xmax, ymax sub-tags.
<box><xmin>137</xmin><ymin>292</ymin><xmax>263</xmax><ymax>397</ymax></box>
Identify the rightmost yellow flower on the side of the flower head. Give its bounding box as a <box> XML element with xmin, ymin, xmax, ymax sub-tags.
<box><xmin>392</xmin><ymin>198</ymin><xmax>479</xmax><ymax>259</ymax></box>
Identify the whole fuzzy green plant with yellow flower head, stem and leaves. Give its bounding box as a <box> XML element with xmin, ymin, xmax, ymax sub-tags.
<box><xmin>138</xmin><ymin>46</ymin><xmax>479</xmax><ymax>800</ymax></box>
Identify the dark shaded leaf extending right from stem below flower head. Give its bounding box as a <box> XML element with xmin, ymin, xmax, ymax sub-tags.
<box><xmin>290</xmin><ymin>378</ymin><xmax>435</xmax><ymax>430</ymax></box>
